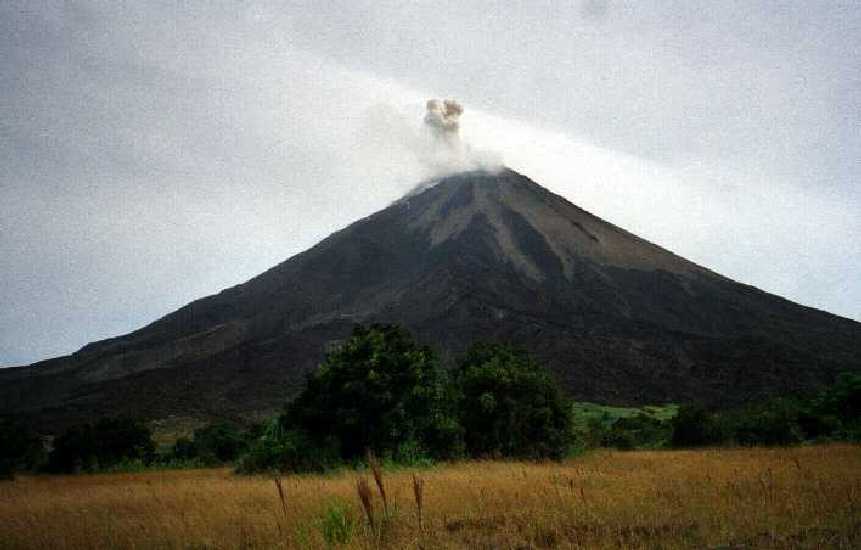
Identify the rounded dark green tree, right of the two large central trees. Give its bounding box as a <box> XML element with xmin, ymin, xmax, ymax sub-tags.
<box><xmin>456</xmin><ymin>344</ymin><xmax>571</xmax><ymax>459</ymax></box>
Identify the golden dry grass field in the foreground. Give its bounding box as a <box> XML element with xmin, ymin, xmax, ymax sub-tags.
<box><xmin>0</xmin><ymin>445</ymin><xmax>861</xmax><ymax>549</ymax></box>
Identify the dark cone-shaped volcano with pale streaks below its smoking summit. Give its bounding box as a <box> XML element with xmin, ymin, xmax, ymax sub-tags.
<box><xmin>0</xmin><ymin>169</ymin><xmax>861</xmax><ymax>432</ymax></box>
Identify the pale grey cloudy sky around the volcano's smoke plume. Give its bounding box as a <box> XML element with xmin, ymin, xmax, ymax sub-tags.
<box><xmin>0</xmin><ymin>0</ymin><xmax>861</xmax><ymax>366</ymax></box>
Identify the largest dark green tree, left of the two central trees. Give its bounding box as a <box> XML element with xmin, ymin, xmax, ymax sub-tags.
<box><xmin>282</xmin><ymin>325</ymin><xmax>461</xmax><ymax>460</ymax></box>
